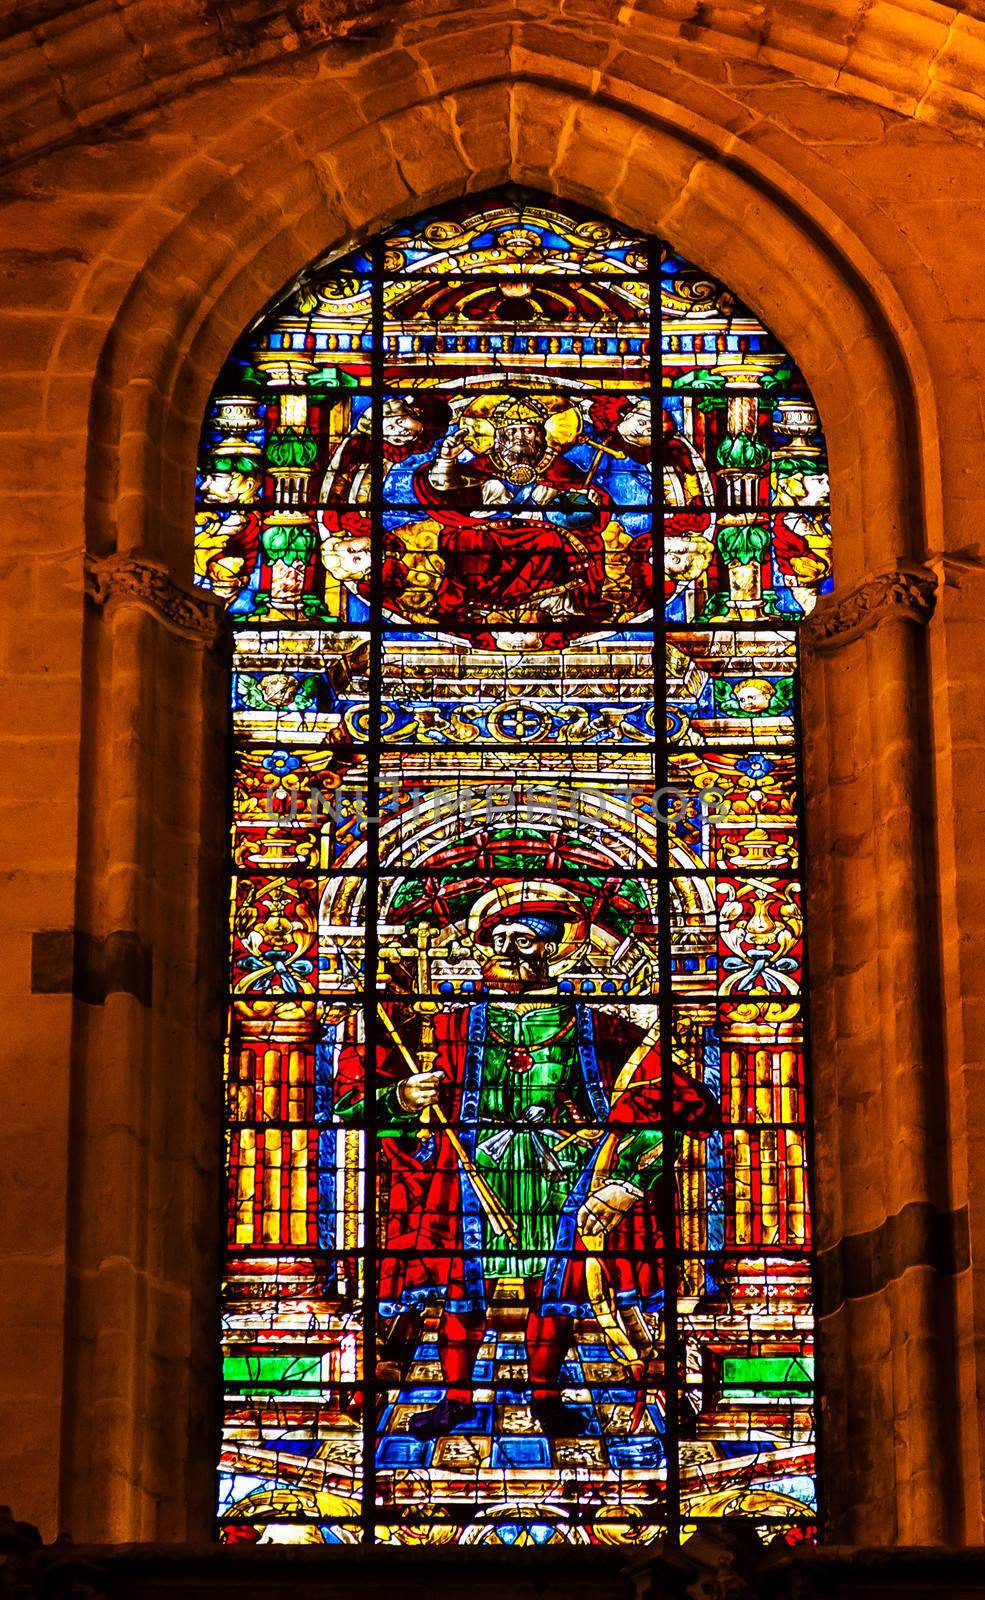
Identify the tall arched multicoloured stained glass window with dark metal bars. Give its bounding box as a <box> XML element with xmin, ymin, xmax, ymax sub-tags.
<box><xmin>197</xmin><ymin>190</ymin><xmax>830</xmax><ymax>1546</ymax></box>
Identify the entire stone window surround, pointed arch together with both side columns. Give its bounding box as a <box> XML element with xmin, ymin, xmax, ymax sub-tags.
<box><xmin>65</xmin><ymin>70</ymin><xmax>975</xmax><ymax>1542</ymax></box>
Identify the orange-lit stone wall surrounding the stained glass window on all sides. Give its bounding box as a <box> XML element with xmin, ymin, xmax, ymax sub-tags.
<box><xmin>0</xmin><ymin>0</ymin><xmax>985</xmax><ymax>1544</ymax></box>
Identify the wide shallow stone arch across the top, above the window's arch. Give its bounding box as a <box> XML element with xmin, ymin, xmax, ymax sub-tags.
<box><xmin>0</xmin><ymin>0</ymin><xmax>983</xmax><ymax>160</ymax></box>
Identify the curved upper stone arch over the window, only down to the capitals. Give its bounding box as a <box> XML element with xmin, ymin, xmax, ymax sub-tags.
<box><xmin>75</xmin><ymin>76</ymin><xmax>940</xmax><ymax>579</ymax></box>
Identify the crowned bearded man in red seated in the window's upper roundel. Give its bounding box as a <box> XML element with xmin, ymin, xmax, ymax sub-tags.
<box><xmin>414</xmin><ymin>398</ymin><xmax>609</xmax><ymax>626</ymax></box>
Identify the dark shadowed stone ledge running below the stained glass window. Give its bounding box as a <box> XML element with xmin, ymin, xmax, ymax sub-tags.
<box><xmin>0</xmin><ymin>1507</ymin><xmax>985</xmax><ymax>1600</ymax></box>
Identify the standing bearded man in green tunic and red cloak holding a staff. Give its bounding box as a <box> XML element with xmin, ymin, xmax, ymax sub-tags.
<box><xmin>336</xmin><ymin>880</ymin><xmax>716</xmax><ymax>1438</ymax></box>
